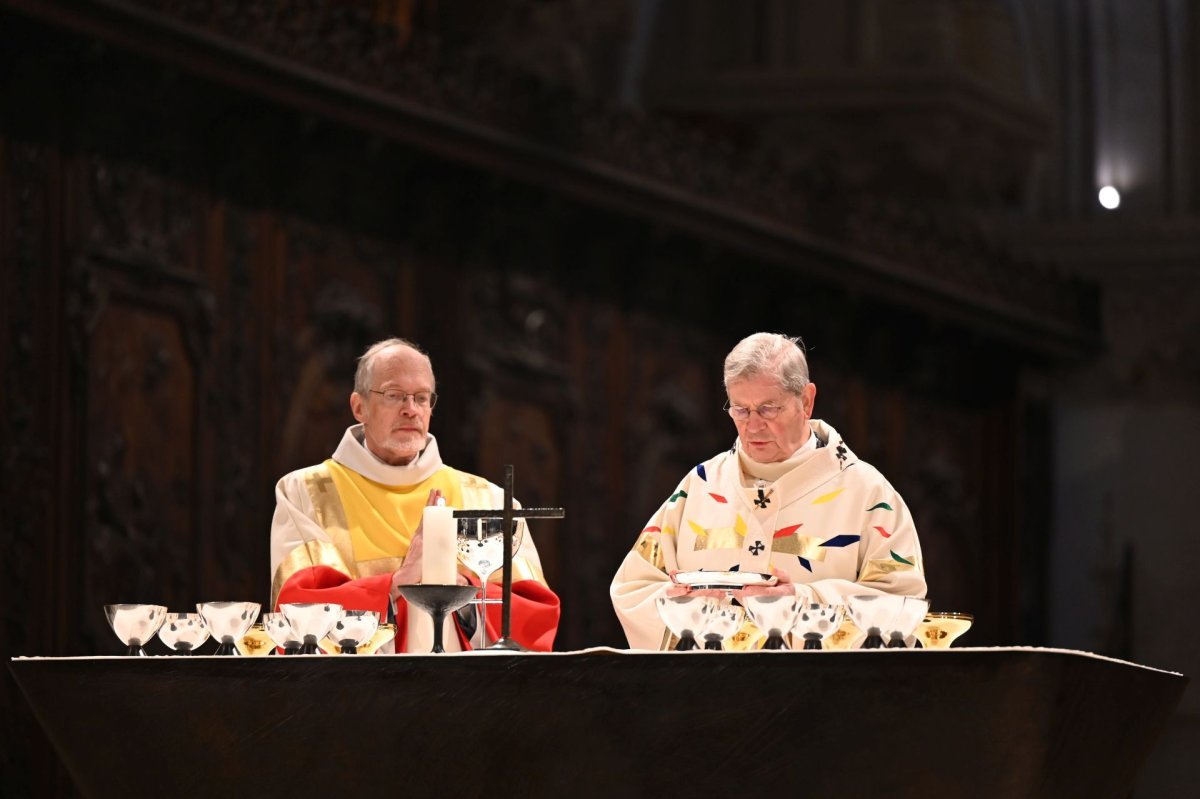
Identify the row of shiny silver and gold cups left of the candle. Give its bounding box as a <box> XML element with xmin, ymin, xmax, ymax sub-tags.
<box><xmin>104</xmin><ymin>602</ymin><xmax>395</xmax><ymax>655</ymax></box>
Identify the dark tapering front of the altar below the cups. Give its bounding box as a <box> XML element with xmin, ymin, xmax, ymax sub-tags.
<box><xmin>12</xmin><ymin>649</ymin><xmax>1187</xmax><ymax>798</ymax></box>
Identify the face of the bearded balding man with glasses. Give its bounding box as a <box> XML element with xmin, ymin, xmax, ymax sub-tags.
<box><xmin>350</xmin><ymin>347</ymin><xmax>433</xmax><ymax>465</ymax></box>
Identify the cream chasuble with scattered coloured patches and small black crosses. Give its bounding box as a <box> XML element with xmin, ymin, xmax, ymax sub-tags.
<box><xmin>610</xmin><ymin>420</ymin><xmax>925</xmax><ymax>649</ymax></box>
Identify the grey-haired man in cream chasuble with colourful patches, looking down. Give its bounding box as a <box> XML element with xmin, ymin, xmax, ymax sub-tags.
<box><xmin>610</xmin><ymin>334</ymin><xmax>925</xmax><ymax>649</ymax></box>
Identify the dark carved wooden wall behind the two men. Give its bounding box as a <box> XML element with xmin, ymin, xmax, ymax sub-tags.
<box><xmin>0</xmin><ymin>4</ymin><xmax>1113</xmax><ymax>795</ymax></box>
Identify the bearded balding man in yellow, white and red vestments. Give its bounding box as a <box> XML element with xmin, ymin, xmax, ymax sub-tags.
<box><xmin>271</xmin><ymin>338</ymin><xmax>559</xmax><ymax>651</ymax></box>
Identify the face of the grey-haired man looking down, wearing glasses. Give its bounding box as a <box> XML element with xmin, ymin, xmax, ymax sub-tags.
<box><xmin>726</xmin><ymin>374</ymin><xmax>817</xmax><ymax>463</ymax></box>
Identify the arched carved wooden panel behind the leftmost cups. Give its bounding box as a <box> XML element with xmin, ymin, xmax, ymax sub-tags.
<box><xmin>80</xmin><ymin>300</ymin><xmax>196</xmax><ymax>654</ymax></box>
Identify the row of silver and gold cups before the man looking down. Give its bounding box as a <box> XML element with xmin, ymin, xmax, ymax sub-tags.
<box><xmin>658</xmin><ymin>593</ymin><xmax>973</xmax><ymax>650</ymax></box>
